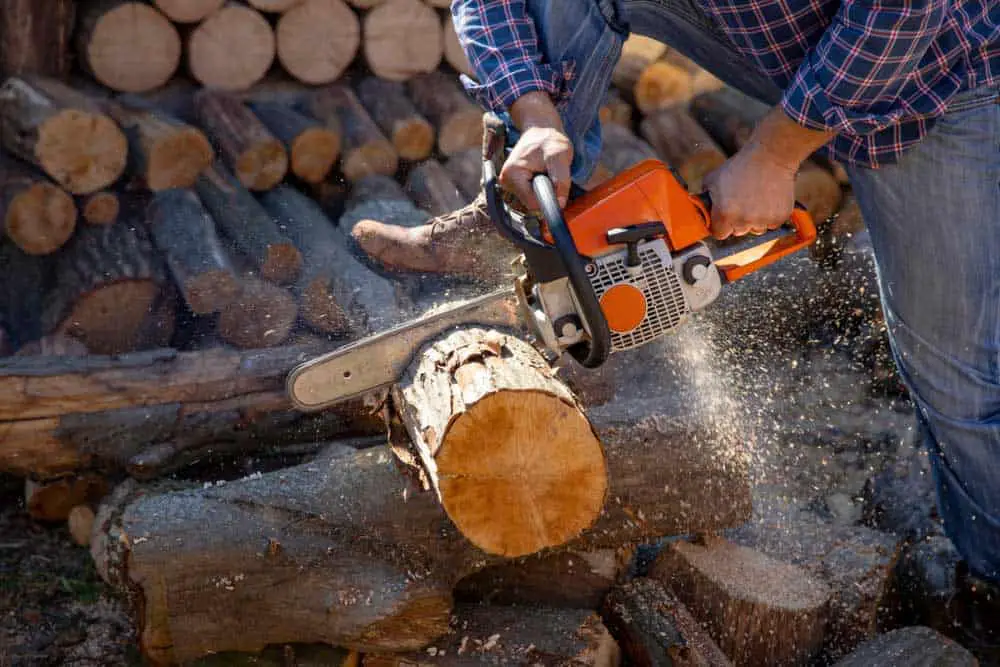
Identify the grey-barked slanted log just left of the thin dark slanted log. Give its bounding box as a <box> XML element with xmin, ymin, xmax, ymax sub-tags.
<box><xmin>149</xmin><ymin>189</ymin><xmax>239</xmax><ymax>315</ymax></box>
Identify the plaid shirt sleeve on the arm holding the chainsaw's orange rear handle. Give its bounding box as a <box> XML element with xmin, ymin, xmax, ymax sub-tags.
<box><xmin>781</xmin><ymin>0</ymin><xmax>948</xmax><ymax>136</ymax></box>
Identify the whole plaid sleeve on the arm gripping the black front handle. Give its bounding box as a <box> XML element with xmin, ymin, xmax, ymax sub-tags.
<box><xmin>451</xmin><ymin>0</ymin><xmax>573</xmax><ymax>113</ymax></box>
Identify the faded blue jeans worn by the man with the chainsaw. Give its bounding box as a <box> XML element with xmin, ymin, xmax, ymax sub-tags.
<box><xmin>514</xmin><ymin>0</ymin><xmax>1000</xmax><ymax>581</ymax></box>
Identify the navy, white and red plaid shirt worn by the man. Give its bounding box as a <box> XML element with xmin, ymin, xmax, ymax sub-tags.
<box><xmin>452</xmin><ymin>0</ymin><xmax>1000</xmax><ymax>167</ymax></box>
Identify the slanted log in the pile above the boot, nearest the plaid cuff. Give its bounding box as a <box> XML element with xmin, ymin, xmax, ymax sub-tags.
<box><xmin>407</xmin><ymin>70</ymin><xmax>483</xmax><ymax>157</ymax></box>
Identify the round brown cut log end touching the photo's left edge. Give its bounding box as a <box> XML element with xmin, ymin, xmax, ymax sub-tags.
<box><xmin>4</xmin><ymin>182</ymin><xmax>77</xmax><ymax>255</ymax></box>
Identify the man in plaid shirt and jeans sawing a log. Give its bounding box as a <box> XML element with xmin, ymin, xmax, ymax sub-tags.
<box><xmin>357</xmin><ymin>0</ymin><xmax>1000</xmax><ymax>652</ymax></box>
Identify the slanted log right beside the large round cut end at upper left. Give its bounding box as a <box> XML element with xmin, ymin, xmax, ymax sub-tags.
<box><xmin>105</xmin><ymin>98</ymin><xmax>214</xmax><ymax>192</ymax></box>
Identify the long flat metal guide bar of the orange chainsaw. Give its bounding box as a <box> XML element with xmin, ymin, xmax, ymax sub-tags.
<box><xmin>287</xmin><ymin>287</ymin><xmax>524</xmax><ymax>412</ymax></box>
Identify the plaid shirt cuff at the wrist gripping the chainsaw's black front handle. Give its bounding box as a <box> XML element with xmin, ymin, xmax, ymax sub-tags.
<box><xmin>460</xmin><ymin>61</ymin><xmax>575</xmax><ymax>113</ymax></box>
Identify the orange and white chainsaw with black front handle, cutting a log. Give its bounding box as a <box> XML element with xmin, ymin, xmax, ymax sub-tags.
<box><xmin>287</xmin><ymin>114</ymin><xmax>816</xmax><ymax>411</ymax></box>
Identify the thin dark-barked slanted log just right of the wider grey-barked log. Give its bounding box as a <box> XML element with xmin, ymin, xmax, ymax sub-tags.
<box><xmin>195</xmin><ymin>161</ymin><xmax>302</xmax><ymax>285</ymax></box>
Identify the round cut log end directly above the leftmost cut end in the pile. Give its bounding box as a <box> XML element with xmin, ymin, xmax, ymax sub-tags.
<box><xmin>35</xmin><ymin>109</ymin><xmax>128</xmax><ymax>194</ymax></box>
